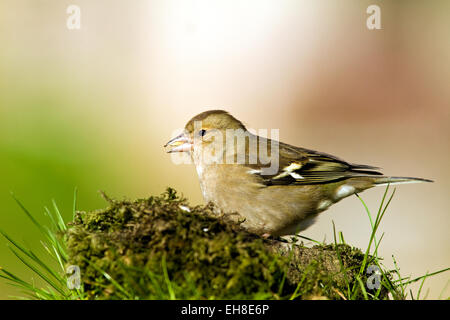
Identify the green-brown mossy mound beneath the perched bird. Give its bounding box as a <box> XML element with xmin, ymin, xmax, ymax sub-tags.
<box><xmin>67</xmin><ymin>189</ymin><xmax>390</xmax><ymax>299</ymax></box>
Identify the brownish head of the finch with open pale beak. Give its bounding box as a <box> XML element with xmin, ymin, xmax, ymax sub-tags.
<box><xmin>165</xmin><ymin>110</ymin><xmax>246</xmax><ymax>153</ymax></box>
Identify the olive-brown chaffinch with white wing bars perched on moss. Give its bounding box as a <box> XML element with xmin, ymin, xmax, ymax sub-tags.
<box><xmin>165</xmin><ymin>110</ymin><xmax>432</xmax><ymax>236</ymax></box>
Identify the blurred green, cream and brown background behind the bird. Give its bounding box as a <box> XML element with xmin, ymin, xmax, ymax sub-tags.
<box><xmin>0</xmin><ymin>0</ymin><xmax>450</xmax><ymax>299</ymax></box>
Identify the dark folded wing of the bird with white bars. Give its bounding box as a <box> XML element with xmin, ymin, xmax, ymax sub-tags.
<box><xmin>251</xmin><ymin>142</ymin><xmax>382</xmax><ymax>185</ymax></box>
